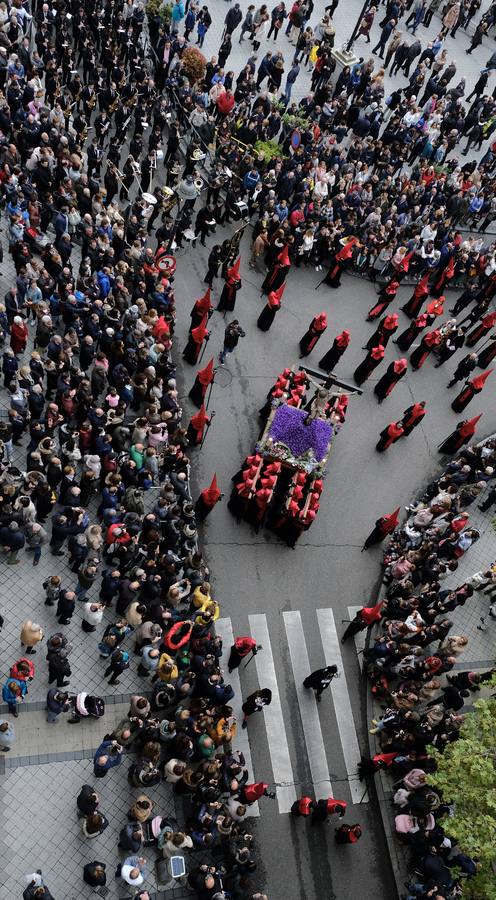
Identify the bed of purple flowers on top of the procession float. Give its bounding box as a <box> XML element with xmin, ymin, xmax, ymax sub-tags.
<box><xmin>267</xmin><ymin>404</ymin><xmax>333</xmax><ymax>462</ymax></box>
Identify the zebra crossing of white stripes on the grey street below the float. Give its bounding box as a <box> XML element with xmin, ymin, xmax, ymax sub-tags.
<box><xmin>216</xmin><ymin>607</ymin><xmax>368</xmax><ymax>816</ymax></box>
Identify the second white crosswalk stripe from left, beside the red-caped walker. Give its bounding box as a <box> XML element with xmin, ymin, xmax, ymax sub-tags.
<box><xmin>248</xmin><ymin>615</ymin><xmax>296</xmax><ymax>813</ymax></box>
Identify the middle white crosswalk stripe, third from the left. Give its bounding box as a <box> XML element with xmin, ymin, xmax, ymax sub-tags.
<box><xmin>283</xmin><ymin>612</ymin><xmax>334</xmax><ymax>798</ymax></box>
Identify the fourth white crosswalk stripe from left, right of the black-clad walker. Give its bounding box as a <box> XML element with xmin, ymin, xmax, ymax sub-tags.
<box><xmin>317</xmin><ymin>609</ymin><xmax>368</xmax><ymax>803</ymax></box>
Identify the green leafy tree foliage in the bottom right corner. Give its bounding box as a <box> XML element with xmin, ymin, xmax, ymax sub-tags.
<box><xmin>428</xmin><ymin>699</ymin><xmax>496</xmax><ymax>900</ymax></box>
